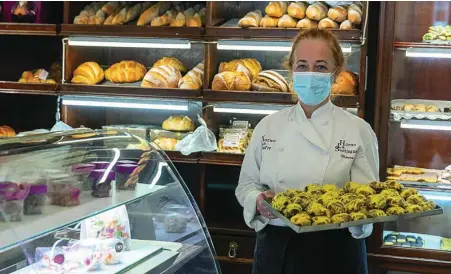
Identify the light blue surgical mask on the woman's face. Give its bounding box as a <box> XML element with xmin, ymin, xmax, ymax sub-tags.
<box><xmin>293</xmin><ymin>72</ymin><xmax>333</xmax><ymax>106</ymax></box>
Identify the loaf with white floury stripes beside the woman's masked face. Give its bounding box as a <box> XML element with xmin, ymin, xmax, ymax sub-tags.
<box><xmin>252</xmin><ymin>70</ymin><xmax>289</xmax><ymax>92</ymax></box>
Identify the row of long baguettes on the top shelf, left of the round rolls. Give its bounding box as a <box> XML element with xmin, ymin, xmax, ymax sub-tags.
<box><xmin>74</xmin><ymin>1</ymin><xmax>205</xmax><ymax>27</ymax></box>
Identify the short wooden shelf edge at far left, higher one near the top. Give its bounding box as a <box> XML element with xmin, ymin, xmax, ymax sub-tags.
<box><xmin>0</xmin><ymin>23</ymin><xmax>58</xmax><ymax>36</ymax></box>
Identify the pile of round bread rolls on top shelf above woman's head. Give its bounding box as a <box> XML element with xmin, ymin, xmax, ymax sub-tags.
<box><xmin>238</xmin><ymin>1</ymin><xmax>363</xmax><ymax>30</ymax></box>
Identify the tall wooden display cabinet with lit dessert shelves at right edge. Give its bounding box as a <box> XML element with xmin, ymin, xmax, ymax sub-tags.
<box><xmin>369</xmin><ymin>1</ymin><xmax>451</xmax><ymax>273</ymax></box>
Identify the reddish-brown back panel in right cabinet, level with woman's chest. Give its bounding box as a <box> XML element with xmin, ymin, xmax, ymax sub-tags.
<box><xmin>388</xmin><ymin>122</ymin><xmax>451</xmax><ymax>169</ymax></box>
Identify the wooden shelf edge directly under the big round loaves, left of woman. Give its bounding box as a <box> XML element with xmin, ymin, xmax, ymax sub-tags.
<box><xmin>60</xmin><ymin>84</ymin><xmax>201</xmax><ymax>99</ymax></box>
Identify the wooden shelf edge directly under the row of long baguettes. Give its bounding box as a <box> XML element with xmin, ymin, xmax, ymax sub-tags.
<box><xmin>60</xmin><ymin>24</ymin><xmax>204</xmax><ymax>40</ymax></box>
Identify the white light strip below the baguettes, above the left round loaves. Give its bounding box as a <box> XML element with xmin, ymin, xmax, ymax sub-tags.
<box><xmin>67</xmin><ymin>37</ymin><xmax>191</xmax><ymax>49</ymax></box>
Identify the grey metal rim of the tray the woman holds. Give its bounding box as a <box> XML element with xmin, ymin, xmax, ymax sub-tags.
<box><xmin>263</xmin><ymin>201</ymin><xmax>443</xmax><ymax>233</ymax></box>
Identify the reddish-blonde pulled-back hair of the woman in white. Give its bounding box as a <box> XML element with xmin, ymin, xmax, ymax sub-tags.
<box><xmin>286</xmin><ymin>29</ymin><xmax>345</xmax><ymax>71</ymax></box>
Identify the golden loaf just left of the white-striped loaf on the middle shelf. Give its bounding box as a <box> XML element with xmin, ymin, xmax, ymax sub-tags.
<box><xmin>211</xmin><ymin>71</ymin><xmax>251</xmax><ymax>91</ymax></box>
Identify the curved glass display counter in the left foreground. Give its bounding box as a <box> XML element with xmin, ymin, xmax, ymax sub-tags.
<box><xmin>0</xmin><ymin>129</ymin><xmax>220</xmax><ymax>274</ymax></box>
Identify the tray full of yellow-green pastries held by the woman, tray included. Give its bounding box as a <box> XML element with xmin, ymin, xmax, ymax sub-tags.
<box><xmin>265</xmin><ymin>181</ymin><xmax>443</xmax><ymax>233</ymax></box>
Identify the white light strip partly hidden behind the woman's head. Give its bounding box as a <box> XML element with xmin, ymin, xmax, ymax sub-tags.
<box><xmin>217</xmin><ymin>40</ymin><xmax>352</xmax><ymax>53</ymax></box>
